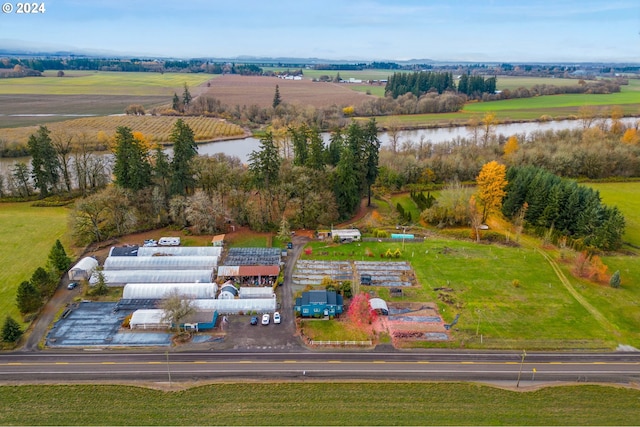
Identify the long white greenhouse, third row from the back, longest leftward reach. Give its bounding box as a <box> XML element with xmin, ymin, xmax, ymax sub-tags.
<box><xmin>89</xmin><ymin>270</ymin><xmax>213</xmax><ymax>286</ymax></box>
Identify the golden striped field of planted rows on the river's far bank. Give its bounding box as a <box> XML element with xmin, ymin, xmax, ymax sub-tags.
<box><xmin>2</xmin><ymin>116</ymin><xmax>246</xmax><ymax>144</ymax></box>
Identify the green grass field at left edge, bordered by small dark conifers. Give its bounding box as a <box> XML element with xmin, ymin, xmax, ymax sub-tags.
<box><xmin>0</xmin><ymin>203</ymin><xmax>73</xmax><ymax>322</ymax></box>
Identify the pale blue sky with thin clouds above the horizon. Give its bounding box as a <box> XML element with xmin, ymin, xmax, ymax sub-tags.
<box><xmin>0</xmin><ymin>0</ymin><xmax>640</xmax><ymax>63</ymax></box>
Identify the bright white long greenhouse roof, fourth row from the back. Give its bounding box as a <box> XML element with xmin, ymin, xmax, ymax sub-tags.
<box><xmin>122</xmin><ymin>283</ymin><xmax>218</xmax><ymax>299</ymax></box>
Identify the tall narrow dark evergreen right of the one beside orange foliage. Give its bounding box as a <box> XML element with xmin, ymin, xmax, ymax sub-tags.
<box><xmin>169</xmin><ymin>119</ymin><xmax>198</xmax><ymax>195</ymax></box>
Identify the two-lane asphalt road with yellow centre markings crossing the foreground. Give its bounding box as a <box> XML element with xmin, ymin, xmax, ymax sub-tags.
<box><xmin>0</xmin><ymin>350</ymin><xmax>640</xmax><ymax>386</ymax></box>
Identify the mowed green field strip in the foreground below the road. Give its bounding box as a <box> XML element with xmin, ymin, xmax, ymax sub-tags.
<box><xmin>0</xmin><ymin>382</ymin><xmax>640</xmax><ymax>426</ymax></box>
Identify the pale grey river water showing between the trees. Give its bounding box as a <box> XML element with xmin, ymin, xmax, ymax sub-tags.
<box><xmin>0</xmin><ymin>118</ymin><xmax>638</xmax><ymax>174</ymax></box>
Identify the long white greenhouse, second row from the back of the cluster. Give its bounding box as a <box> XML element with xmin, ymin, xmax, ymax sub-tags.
<box><xmin>104</xmin><ymin>256</ymin><xmax>218</xmax><ymax>271</ymax></box>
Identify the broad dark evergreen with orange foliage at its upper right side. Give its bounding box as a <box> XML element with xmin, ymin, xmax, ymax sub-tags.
<box><xmin>113</xmin><ymin>126</ymin><xmax>151</xmax><ymax>191</ymax></box>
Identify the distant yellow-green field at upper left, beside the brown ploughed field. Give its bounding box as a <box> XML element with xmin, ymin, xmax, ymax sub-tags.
<box><xmin>0</xmin><ymin>71</ymin><xmax>214</xmax><ymax>96</ymax></box>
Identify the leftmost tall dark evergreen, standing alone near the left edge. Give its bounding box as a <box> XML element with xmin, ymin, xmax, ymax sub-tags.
<box><xmin>27</xmin><ymin>126</ymin><xmax>61</xmax><ymax>197</ymax></box>
